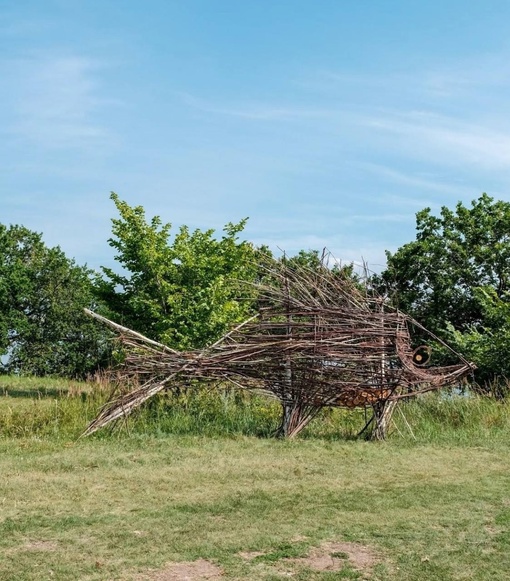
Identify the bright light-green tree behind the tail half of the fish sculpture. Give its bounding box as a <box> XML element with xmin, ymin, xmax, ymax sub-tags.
<box><xmin>97</xmin><ymin>193</ymin><xmax>257</xmax><ymax>350</ymax></box>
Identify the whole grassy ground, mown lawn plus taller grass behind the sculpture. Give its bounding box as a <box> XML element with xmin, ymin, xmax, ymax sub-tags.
<box><xmin>0</xmin><ymin>378</ymin><xmax>510</xmax><ymax>581</ymax></box>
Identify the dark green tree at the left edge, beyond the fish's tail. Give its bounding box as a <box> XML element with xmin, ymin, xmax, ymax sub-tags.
<box><xmin>0</xmin><ymin>224</ymin><xmax>109</xmax><ymax>377</ymax></box>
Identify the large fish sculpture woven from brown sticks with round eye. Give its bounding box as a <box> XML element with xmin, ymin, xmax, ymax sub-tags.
<box><xmin>84</xmin><ymin>262</ymin><xmax>474</xmax><ymax>439</ymax></box>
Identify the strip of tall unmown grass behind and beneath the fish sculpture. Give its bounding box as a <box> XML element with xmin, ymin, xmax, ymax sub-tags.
<box><xmin>0</xmin><ymin>377</ymin><xmax>510</xmax><ymax>445</ymax></box>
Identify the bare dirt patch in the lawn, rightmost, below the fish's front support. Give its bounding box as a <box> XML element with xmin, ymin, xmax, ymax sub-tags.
<box><xmin>285</xmin><ymin>542</ymin><xmax>379</xmax><ymax>572</ymax></box>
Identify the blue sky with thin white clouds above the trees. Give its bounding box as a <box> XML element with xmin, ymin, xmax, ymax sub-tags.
<box><xmin>0</xmin><ymin>0</ymin><xmax>510</xmax><ymax>270</ymax></box>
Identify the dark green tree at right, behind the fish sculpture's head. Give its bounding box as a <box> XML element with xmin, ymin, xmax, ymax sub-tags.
<box><xmin>380</xmin><ymin>194</ymin><xmax>510</xmax><ymax>381</ymax></box>
